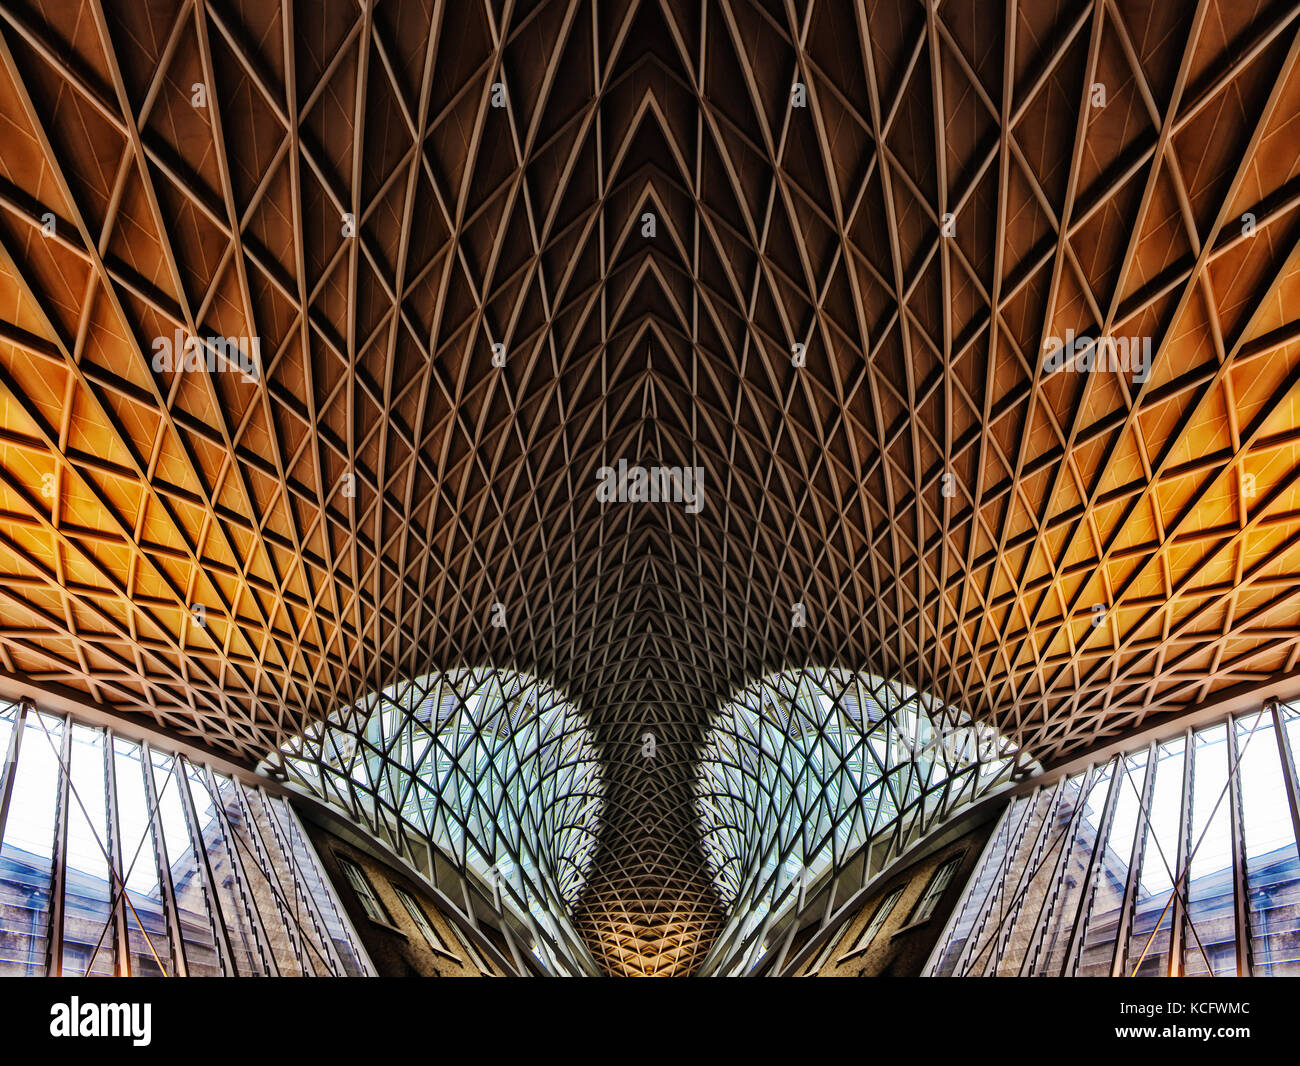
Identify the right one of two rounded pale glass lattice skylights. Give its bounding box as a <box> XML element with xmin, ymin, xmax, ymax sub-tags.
<box><xmin>699</xmin><ymin>670</ymin><xmax>1037</xmax><ymax>958</ymax></box>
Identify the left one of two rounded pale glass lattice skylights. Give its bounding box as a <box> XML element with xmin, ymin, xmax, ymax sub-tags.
<box><xmin>267</xmin><ymin>670</ymin><xmax>601</xmax><ymax>944</ymax></box>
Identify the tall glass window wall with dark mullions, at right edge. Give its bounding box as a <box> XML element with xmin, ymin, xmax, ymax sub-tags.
<box><xmin>927</xmin><ymin>705</ymin><xmax>1300</xmax><ymax>976</ymax></box>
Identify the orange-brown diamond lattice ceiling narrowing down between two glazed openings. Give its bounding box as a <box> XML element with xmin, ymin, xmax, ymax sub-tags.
<box><xmin>0</xmin><ymin>0</ymin><xmax>1300</xmax><ymax>974</ymax></box>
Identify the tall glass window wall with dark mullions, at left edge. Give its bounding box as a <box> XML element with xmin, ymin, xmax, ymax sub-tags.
<box><xmin>0</xmin><ymin>703</ymin><xmax>372</xmax><ymax>976</ymax></box>
